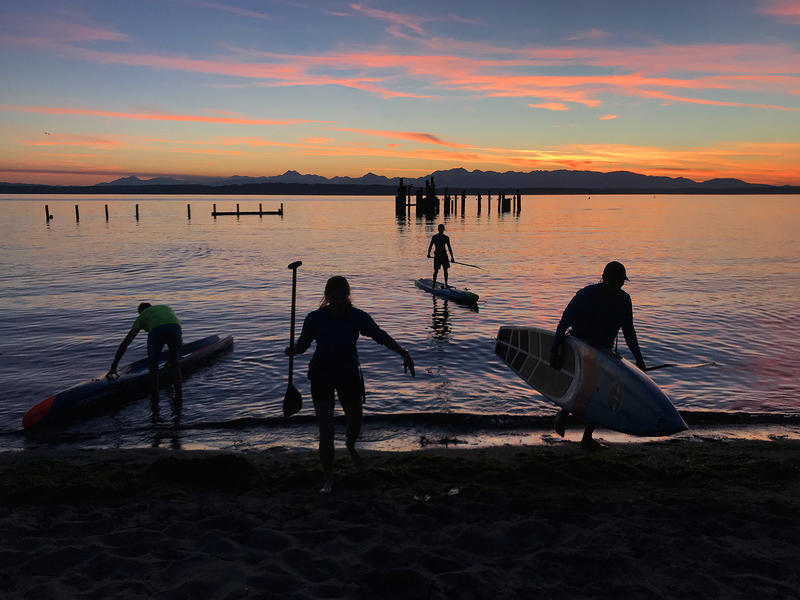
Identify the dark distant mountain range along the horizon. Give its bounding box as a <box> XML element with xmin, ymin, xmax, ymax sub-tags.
<box><xmin>0</xmin><ymin>168</ymin><xmax>800</xmax><ymax>194</ymax></box>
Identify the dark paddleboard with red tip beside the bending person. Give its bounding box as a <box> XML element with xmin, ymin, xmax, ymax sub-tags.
<box><xmin>22</xmin><ymin>335</ymin><xmax>233</xmax><ymax>429</ymax></box>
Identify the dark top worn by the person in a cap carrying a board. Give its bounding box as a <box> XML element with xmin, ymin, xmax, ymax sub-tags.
<box><xmin>551</xmin><ymin>283</ymin><xmax>642</xmax><ymax>361</ymax></box>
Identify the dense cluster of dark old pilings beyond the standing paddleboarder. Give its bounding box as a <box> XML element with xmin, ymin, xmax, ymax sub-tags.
<box><xmin>394</xmin><ymin>177</ymin><xmax>522</xmax><ymax>217</ymax></box>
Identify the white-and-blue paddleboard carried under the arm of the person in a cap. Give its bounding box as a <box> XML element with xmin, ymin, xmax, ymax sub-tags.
<box><xmin>495</xmin><ymin>327</ymin><xmax>688</xmax><ymax>436</ymax></box>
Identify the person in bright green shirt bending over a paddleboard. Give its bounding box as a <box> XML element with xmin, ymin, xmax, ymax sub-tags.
<box><xmin>106</xmin><ymin>302</ymin><xmax>183</xmax><ymax>422</ymax></box>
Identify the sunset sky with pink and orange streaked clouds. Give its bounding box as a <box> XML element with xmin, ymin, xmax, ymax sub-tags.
<box><xmin>0</xmin><ymin>0</ymin><xmax>800</xmax><ymax>185</ymax></box>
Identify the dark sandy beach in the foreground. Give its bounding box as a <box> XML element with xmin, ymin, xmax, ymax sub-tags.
<box><xmin>0</xmin><ymin>441</ymin><xmax>800</xmax><ymax>600</ymax></box>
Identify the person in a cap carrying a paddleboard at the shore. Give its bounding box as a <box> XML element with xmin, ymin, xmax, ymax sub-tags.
<box><xmin>550</xmin><ymin>261</ymin><xmax>646</xmax><ymax>449</ymax></box>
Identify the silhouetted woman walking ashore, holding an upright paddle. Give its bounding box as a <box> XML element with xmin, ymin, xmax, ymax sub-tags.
<box><xmin>285</xmin><ymin>276</ymin><xmax>415</xmax><ymax>494</ymax></box>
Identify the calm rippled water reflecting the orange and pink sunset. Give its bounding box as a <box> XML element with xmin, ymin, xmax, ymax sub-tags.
<box><xmin>0</xmin><ymin>196</ymin><xmax>800</xmax><ymax>448</ymax></box>
